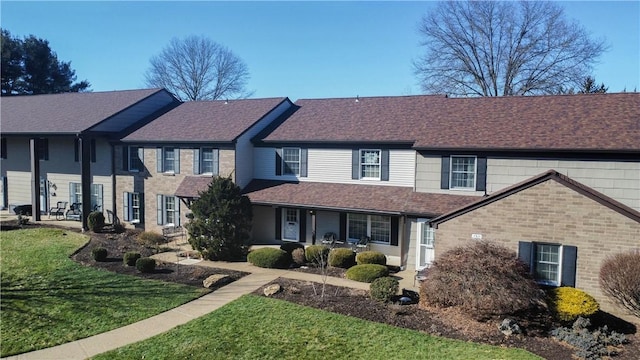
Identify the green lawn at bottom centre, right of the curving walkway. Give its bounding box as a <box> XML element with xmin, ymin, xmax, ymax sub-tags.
<box><xmin>94</xmin><ymin>295</ymin><xmax>539</xmax><ymax>360</ymax></box>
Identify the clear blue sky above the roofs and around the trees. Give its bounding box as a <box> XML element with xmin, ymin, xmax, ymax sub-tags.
<box><xmin>0</xmin><ymin>0</ymin><xmax>640</xmax><ymax>101</ymax></box>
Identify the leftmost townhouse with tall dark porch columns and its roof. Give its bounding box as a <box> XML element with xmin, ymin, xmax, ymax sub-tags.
<box><xmin>0</xmin><ymin>89</ymin><xmax>178</xmax><ymax>229</ymax></box>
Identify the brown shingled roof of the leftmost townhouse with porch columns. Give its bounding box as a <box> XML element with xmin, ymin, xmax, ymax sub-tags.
<box><xmin>0</xmin><ymin>89</ymin><xmax>166</xmax><ymax>134</ymax></box>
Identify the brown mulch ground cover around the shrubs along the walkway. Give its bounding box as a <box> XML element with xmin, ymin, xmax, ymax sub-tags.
<box><xmin>2</xmin><ymin>224</ymin><xmax>640</xmax><ymax>360</ymax></box>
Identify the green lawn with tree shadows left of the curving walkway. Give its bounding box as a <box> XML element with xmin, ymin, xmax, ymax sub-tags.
<box><xmin>0</xmin><ymin>228</ymin><xmax>205</xmax><ymax>356</ymax></box>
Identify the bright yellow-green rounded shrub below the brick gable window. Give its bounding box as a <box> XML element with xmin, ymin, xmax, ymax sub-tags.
<box><xmin>549</xmin><ymin>286</ymin><xmax>600</xmax><ymax>321</ymax></box>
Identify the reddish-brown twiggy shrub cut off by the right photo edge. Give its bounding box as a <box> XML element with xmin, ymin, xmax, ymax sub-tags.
<box><xmin>600</xmin><ymin>251</ymin><xmax>640</xmax><ymax>318</ymax></box>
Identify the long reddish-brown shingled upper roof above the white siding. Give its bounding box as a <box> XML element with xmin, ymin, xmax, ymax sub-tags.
<box><xmin>264</xmin><ymin>93</ymin><xmax>640</xmax><ymax>152</ymax></box>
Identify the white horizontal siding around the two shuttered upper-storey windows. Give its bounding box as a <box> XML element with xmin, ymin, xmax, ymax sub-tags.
<box><xmin>253</xmin><ymin>147</ymin><xmax>415</xmax><ymax>187</ymax></box>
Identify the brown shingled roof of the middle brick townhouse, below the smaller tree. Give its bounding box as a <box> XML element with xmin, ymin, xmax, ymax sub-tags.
<box><xmin>123</xmin><ymin>97</ymin><xmax>289</xmax><ymax>142</ymax></box>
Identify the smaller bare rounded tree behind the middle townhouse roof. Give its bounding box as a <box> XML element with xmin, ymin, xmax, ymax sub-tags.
<box><xmin>145</xmin><ymin>36</ymin><xmax>250</xmax><ymax>101</ymax></box>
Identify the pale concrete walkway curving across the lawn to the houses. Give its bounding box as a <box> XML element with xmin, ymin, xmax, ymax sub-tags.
<box><xmin>6</xmin><ymin>252</ymin><xmax>384</xmax><ymax>360</ymax></box>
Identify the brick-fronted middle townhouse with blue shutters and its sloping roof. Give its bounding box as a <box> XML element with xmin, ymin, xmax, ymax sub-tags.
<box><xmin>115</xmin><ymin>98</ymin><xmax>293</xmax><ymax>231</ymax></box>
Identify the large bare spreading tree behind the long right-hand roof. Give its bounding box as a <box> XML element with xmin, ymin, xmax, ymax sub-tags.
<box><xmin>414</xmin><ymin>1</ymin><xmax>606</xmax><ymax>96</ymax></box>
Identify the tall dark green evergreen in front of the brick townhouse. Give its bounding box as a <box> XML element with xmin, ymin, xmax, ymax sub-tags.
<box><xmin>186</xmin><ymin>177</ymin><xmax>253</xmax><ymax>261</ymax></box>
